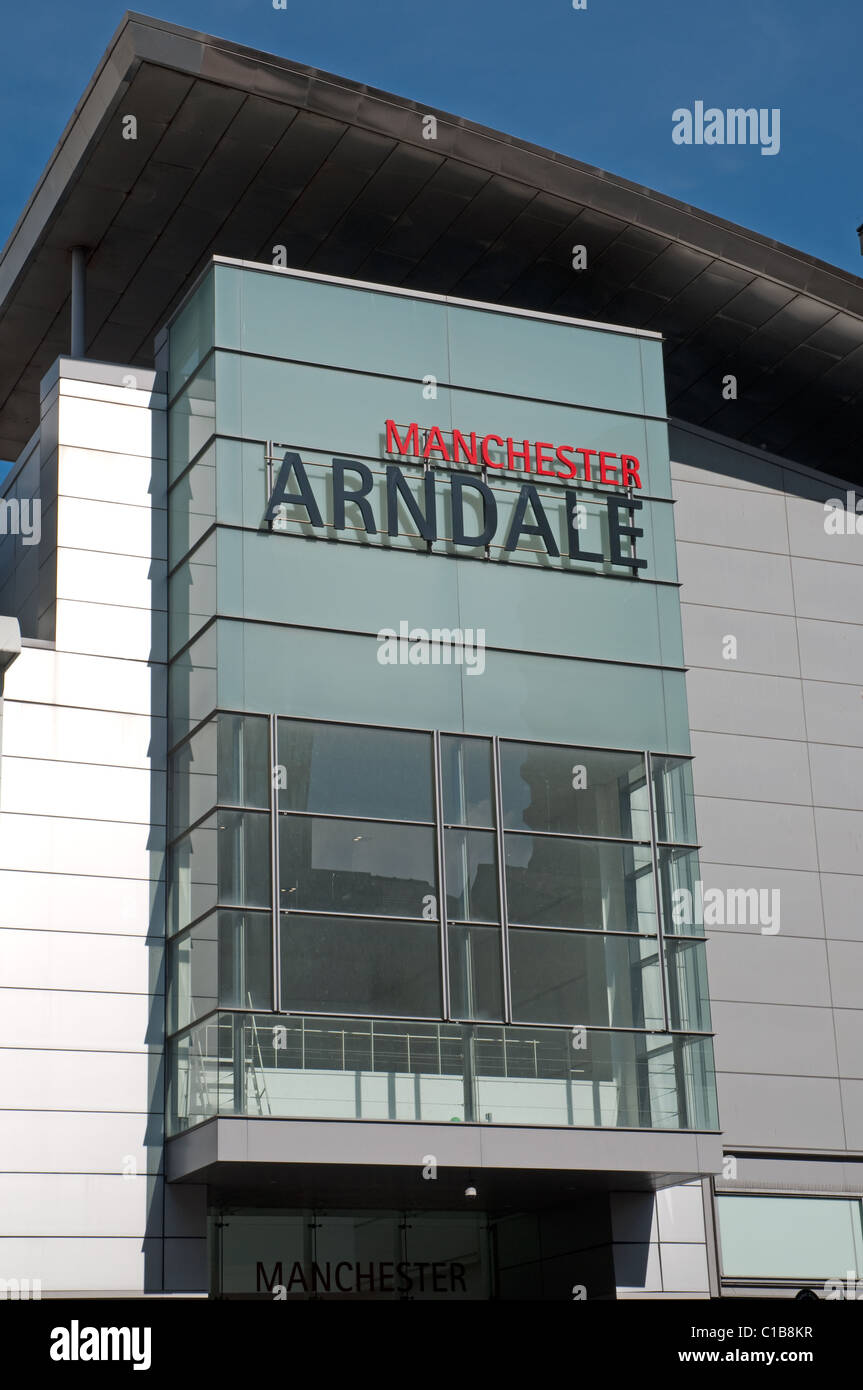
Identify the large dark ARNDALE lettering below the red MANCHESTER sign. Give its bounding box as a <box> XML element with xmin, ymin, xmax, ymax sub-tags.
<box><xmin>264</xmin><ymin>453</ymin><xmax>648</xmax><ymax>574</ymax></box>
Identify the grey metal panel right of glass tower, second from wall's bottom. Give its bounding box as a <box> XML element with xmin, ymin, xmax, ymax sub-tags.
<box><xmin>713</xmin><ymin>1001</ymin><xmax>833</xmax><ymax>1084</ymax></box>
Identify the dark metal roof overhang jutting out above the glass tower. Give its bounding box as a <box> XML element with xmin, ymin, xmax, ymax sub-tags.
<box><xmin>0</xmin><ymin>14</ymin><xmax>863</xmax><ymax>480</ymax></box>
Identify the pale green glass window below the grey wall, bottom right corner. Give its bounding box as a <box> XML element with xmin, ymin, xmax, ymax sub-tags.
<box><xmin>717</xmin><ymin>1197</ymin><xmax>863</xmax><ymax>1278</ymax></box>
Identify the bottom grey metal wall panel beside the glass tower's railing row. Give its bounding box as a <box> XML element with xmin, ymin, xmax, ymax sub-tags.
<box><xmin>717</xmin><ymin>1072</ymin><xmax>845</xmax><ymax>1152</ymax></box>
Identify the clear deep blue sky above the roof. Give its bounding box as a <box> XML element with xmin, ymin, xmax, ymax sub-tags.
<box><xmin>0</xmin><ymin>0</ymin><xmax>863</xmax><ymax>274</ymax></box>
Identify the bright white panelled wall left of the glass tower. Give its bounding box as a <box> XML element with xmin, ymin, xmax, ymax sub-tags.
<box><xmin>0</xmin><ymin>361</ymin><xmax>206</xmax><ymax>1295</ymax></box>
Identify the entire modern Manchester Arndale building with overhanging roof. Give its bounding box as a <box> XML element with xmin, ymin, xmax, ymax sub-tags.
<box><xmin>0</xmin><ymin>15</ymin><xmax>863</xmax><ymax>1300</ymax></box>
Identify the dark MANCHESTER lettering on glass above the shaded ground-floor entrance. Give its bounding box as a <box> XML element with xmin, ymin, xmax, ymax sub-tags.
<box><xmin>256</xmin><ymin>1259</ymin><xmax>467</xmax><ymax>1295</ymax></box>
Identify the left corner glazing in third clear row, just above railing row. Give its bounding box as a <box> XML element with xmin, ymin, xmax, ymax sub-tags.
<box><xmin>168</xmin><ymin>912</ymin><xmax>272</xmax><ymax>1031</ymax></box>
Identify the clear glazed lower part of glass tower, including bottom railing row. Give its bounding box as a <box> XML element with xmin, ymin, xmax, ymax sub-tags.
<box><xmin>168</xmin><ymin>713</ymin><xmax>716</xmax><ymax>1129</ymax></box>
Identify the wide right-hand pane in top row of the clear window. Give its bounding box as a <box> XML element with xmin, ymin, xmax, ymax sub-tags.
<box><xmin>500</xmin><ymin>742</ymin><xmax>650</xmax><ymax>840</ymax></box>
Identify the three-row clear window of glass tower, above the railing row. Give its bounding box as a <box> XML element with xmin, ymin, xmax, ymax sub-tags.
<box><xmin>170</xmin><ymin>713</ymin><xmax>710</xmax><ymax>1045</ymax></box>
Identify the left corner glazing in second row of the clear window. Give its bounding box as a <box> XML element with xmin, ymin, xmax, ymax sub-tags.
<box><xmin>168</xmin><ymin>810</ymin><xmax>270</xmax><ymax>931</ymax></box>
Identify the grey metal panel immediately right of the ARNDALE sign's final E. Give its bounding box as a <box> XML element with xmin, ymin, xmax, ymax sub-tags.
<box><xmin>674</xmin><ymin>480</ymin><xmax>788</xmax><ymax>555</ymax></box>
